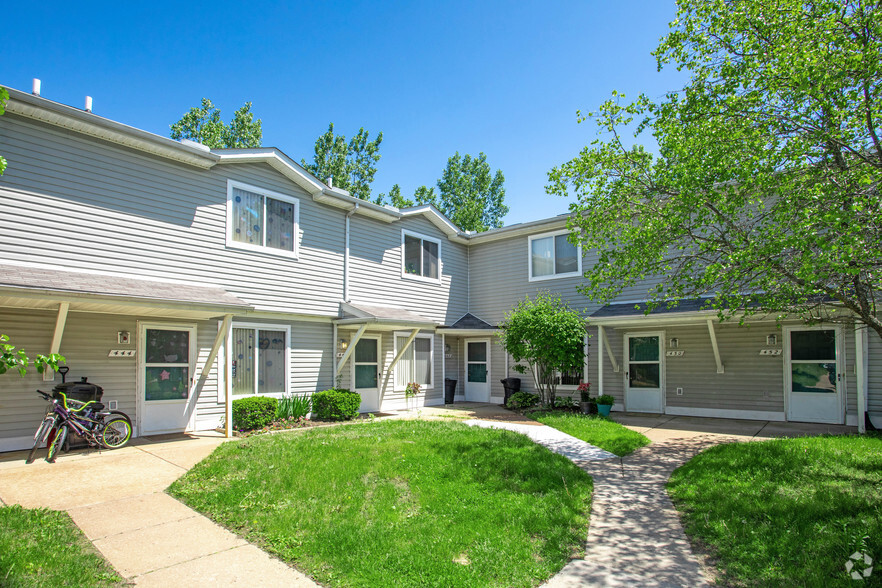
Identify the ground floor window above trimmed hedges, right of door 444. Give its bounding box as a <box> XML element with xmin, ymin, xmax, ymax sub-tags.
<box><xmin>230</xmin><ymin>325</ymin><xmax>291</xmax><ymax>396</ymax></box>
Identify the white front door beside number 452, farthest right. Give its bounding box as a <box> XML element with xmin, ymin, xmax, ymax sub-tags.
<box><xmin>784</xmin><ymin>327</ymin><xmax>843</xmax><ymax>424</ymax></box>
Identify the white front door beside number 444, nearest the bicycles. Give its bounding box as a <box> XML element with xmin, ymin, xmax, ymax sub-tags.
<box><xmin>138</xmin><ymin>324</ymin><xmax>196</xmax><ymax>435</ymax></box>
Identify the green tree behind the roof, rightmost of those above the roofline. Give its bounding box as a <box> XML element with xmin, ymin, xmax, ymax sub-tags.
<box><xmin>432</xmin><ymin>151</ymin><xmax>508</xmax><ymax>232</ymax></box>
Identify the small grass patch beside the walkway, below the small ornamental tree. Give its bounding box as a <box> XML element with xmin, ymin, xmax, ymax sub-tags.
<box><xmin>529</xmin><ymin>411</ymin><xmax>649</xmax><ymax>456</ymax></box>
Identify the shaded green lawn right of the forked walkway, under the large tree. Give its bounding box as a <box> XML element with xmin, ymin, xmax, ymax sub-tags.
<box><xmin>668</xmin><ymin>437</ymin><xmax>882</xmax><ymax>586</ymax></box>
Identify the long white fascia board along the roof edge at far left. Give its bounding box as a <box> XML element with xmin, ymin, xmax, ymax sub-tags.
<box><xmin>6</xmin><ymin>88</ymin><xmax>218</xmax><ymax>169</ymax></box>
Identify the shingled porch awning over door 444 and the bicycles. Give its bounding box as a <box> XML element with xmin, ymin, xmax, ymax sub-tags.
<box><xmin>0</xmin><ymin>264</ymin><xmax>252</xmax><ymax>319</ymax></box>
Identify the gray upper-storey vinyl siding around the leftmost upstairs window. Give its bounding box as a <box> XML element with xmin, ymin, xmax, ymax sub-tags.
<box><xmin>0</xmin><ymin>115</ymin><xmax>344</xmax><ymax>316</ymax></box>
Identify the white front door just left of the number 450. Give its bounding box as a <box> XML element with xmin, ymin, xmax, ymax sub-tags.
<box><xmin>625</xmin><ymin>333</ymin><xmax>664</xmax><ymax>413</ymax></box>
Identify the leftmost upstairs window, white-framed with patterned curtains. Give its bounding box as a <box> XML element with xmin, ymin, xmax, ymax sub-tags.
<box><xmin>227</xmin><ymin>181</ymin><xmax>299</xmax><ymax>255</ymax></box>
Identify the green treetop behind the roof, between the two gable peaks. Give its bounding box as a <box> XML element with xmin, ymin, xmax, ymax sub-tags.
<box><xmin>301</xmin><ymin>123</ymin><xmax>383</xmax><ymax>203</ymax></box>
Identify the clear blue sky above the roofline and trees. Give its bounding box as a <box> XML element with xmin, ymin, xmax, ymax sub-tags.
<box><xmin>0</xmin><ymin>0</ymin><xmax>684</xmax><ymax>225</ymax></box>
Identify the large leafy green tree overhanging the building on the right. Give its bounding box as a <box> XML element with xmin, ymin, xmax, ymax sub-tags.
<box><xmin>548</xmin><ymin>0</ymin><xmax>882</xmax><ymax>336</ymax></box>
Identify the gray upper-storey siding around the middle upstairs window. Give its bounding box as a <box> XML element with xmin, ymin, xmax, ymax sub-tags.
<box><xmin>339</xmin><ymin>216</ymin><xmax>469</xmax><ymax>324</ymax></box>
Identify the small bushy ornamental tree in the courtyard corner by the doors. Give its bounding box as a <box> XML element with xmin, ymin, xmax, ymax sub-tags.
<box><xmin>499</xmin><ymin>292</ymin><xmax>585</xmax><ymax>407</ymax></box>
